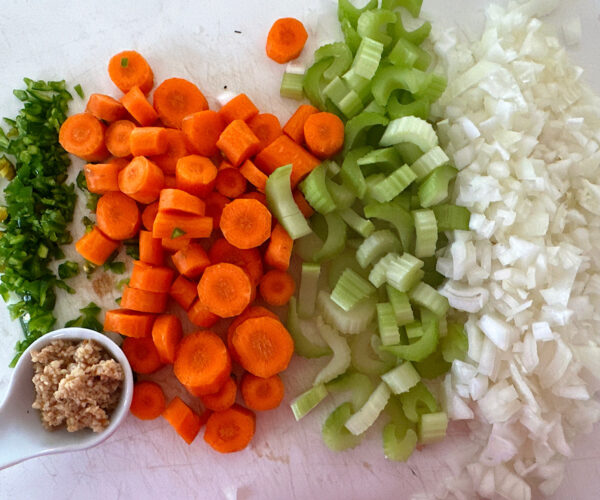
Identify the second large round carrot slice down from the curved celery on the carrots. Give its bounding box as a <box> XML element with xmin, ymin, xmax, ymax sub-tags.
<box><xmin>198</xmin><ymin>262</ymin><xmax>252</xmax><ymax>318</ymax></box>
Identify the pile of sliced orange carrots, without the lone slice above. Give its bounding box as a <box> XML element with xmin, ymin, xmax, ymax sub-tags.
<box><xmin>61</xmin><ymin>47</ymin><xmax>330</xmax><ymax>452</ymax></box>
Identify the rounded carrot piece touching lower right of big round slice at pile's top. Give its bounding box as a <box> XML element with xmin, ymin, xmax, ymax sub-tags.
<box><xmin>181</xmin><ymin>109</ymin><xmax>227</xmax><ymax>156</ymax></box>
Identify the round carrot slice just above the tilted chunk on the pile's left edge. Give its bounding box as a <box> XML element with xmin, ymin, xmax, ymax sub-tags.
<box><xmin>96</xmin><ymin>191</ymin><xmax>141</xmax><ymax>240</ymax></box>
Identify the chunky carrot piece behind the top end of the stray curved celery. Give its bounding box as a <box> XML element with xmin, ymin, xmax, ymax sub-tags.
<box><xmin>254</xmin><ymin>135</ymin><xmax>321</xmax><ymax>188</ymax></box>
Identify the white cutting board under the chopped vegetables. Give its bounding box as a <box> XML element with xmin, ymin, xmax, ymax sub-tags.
<box><xmin>0</xmin><ymin>0</ymin><xmax>600</xmax><ymax>500</ymax></box>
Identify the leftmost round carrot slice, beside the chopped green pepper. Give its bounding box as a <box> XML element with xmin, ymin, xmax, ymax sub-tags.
<box><xmin>58</xmin><ymin>113</ymin><xmax>108</xmax><ymax>162</ymax></box>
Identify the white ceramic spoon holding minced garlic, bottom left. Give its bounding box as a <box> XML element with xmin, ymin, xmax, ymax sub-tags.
<box><xmin>0</xmin><ymin>328</ymin><xmax>133</xmax><ymax>469</ymax></box>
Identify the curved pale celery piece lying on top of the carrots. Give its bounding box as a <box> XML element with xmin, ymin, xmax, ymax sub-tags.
<box><xmin>265</xmin><ymin>164</ymin><xmax>311</xmax><ymax>240</ymax></box>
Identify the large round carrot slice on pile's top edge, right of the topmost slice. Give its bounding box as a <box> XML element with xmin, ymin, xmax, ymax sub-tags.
<box><xmin>153</xmin><ymin>78</ymin><xmax>208</xmax><ymax>128</ymax></box>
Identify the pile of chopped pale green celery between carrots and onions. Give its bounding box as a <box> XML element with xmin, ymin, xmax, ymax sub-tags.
<box><xmin>267</xmin><ymin>0</ymin><xmax>470</xmax><ymax>461</ymax></box>
